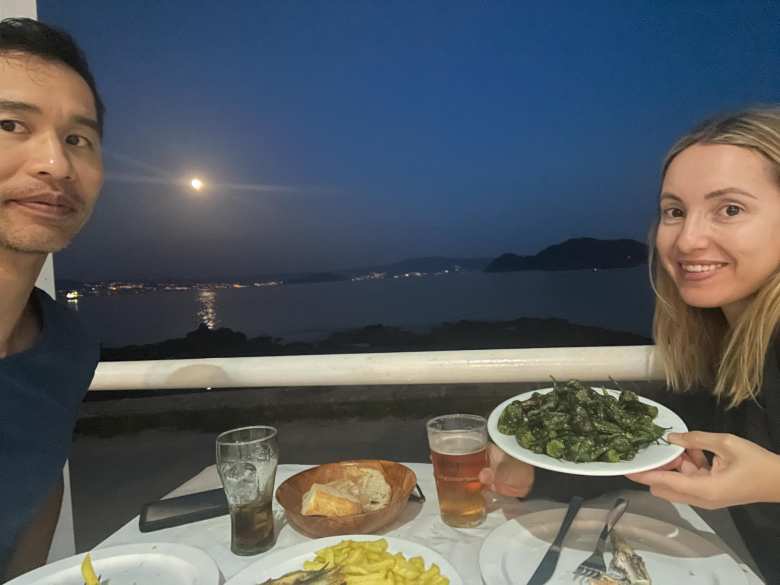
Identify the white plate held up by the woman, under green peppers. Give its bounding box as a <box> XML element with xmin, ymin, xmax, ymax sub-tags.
<box><xmin>488</xmin><ymin>388</ymin><xmax>688</xmax><ymax>475</ymax></box>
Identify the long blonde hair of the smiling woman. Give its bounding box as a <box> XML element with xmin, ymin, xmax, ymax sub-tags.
<box><xmin>649</xmin><ymin>106</ymin><xmax>780</xmax><ymax>408</ymax></box>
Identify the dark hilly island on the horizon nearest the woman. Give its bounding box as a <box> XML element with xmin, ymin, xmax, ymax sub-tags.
<box><xmin>485</xmin><ymin>238</ymin><xmax>647</xmax><ymax>272</ymax></box>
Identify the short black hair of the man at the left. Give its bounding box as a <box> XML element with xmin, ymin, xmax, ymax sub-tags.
<box><xmin>0</xmin><ymin>18</ymin><xmax>106</xmax><ymax>134</ymax></box>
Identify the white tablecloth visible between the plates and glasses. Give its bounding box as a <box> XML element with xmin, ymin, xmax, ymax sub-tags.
<box><xmin>99</xmin><ymin>463</ymin><xmax>762</xmax><ymax>585</ymax></box>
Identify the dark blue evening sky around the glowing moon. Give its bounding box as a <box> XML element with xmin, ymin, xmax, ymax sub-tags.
<box><xmin>38</xmin><ymin>0</ymin><xmax>780</xmax><ymax>279</ymax></box>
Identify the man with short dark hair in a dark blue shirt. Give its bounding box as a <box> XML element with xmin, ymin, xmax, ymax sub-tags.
<box><xmin>0</xmin><ymin>19</ymin><xmax>104</xmax><ymax>581</ymax></box>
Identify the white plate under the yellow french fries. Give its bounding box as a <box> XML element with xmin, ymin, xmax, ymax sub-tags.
<box><xmin>222</xmin><ymin>534</ymin><xmax>463</xmax><ymax>585</ymax></box>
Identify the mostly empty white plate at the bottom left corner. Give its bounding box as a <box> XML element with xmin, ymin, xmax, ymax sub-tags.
<box><xmin>7</xmin><ymin>542</ymin><xmax>221</xmax><ymax>585</ymax></box>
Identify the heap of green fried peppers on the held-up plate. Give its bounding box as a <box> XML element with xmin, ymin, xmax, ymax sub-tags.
<box><xmin>498</xmin><ymin>380</ymin><xmax>666</xmax><ymax>463</ymax></box>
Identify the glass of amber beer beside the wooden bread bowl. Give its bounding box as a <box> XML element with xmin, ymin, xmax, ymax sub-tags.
<box><xmin>427</xmin><ymin>414</ymin><xmax>488</xmax><ymax>528</ymax></box>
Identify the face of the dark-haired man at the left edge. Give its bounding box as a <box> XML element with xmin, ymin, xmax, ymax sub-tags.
<box><xmin>0</xmin><ymin>53</ymin><xmax>103</xmax><ymax>253</ymax></box>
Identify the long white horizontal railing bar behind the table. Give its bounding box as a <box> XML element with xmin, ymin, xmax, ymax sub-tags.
<box><xmin>90</xmin><ymin>345</ymin><xmax>663</xmax><ymax>391</ymax></box>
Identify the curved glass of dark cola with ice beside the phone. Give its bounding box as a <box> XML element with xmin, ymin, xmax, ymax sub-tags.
<box><xmin>217</xmin><ymin>426</ymin><xmax>279</xmax><ymax>555</ymax></box>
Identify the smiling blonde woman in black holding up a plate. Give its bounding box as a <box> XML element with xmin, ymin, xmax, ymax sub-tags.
<box><xmin>480</xmin><ymin>106</ymin><xmax>780</xmax><ymax>583</ymax></box>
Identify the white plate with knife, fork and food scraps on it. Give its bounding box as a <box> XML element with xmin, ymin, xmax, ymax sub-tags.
<box><xmin>479</xmin><ymin>508</ymin><xmax>748</xmax><ymax>585</ymax></box>
